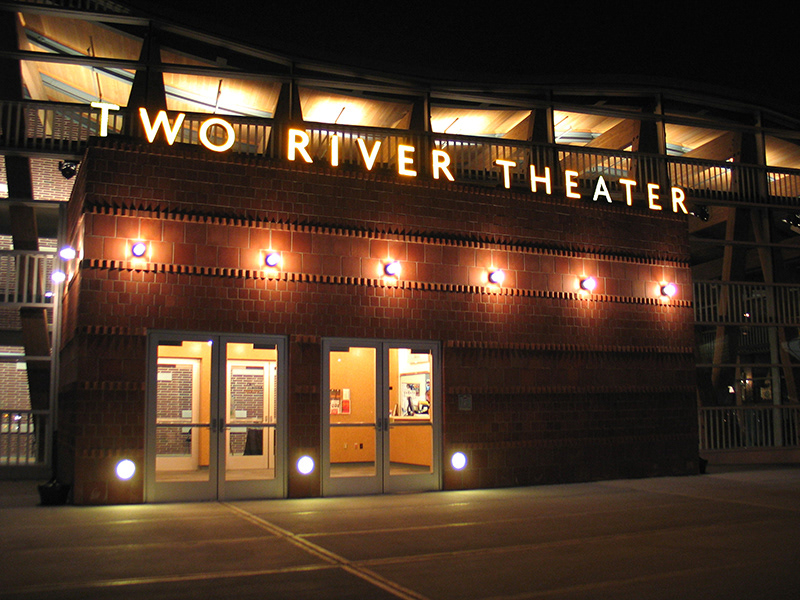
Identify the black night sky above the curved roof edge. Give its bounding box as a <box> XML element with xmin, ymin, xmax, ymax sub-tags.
<box><xmin>131</xmin><ymin>0</ymin><xmax>800</xmax><ymax>116</ymax></box>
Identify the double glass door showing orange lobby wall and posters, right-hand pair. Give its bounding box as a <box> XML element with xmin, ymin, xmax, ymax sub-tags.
<box><xmin>322</xmin><ymin>339</ymin><xmax>441</xmax><ymax>495</ymax></box>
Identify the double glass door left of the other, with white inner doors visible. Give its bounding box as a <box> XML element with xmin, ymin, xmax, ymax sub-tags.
<box><xmin>145</xmin><ymin>332</ymin><xmax>286</xmax><ymax>502</ymax></box>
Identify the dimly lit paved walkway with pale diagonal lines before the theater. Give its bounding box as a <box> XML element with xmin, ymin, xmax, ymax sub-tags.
<box><xmin>0</xmin><ymin>467</ymin><xmax>800</xmax><ymax>600</ymax></box>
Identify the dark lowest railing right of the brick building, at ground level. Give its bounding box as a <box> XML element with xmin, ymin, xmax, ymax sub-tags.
<box><xmin>698</xmin><ymin>406</ymin><xmax>800</xmax><ymax>450</ymax></box>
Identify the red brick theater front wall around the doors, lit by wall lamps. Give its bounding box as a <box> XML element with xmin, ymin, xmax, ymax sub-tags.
<box><xmin>62</xmin><ymin>146</ymin><xmax>697</xmax><ymax>504</ymax></box>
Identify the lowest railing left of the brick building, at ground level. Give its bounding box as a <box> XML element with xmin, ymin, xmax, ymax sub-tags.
<box><xmin>0</xmin><ymin>410</ymin><xmax>49</xmax><ymax>466</ymax></box>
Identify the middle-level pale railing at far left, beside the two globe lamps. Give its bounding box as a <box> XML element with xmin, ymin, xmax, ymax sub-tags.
<box><xmin>0</xmin><ymin>250</ymin><xmax>56</xmax><ymax>306</ymax></box>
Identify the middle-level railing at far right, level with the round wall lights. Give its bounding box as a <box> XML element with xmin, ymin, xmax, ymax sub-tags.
<box><xmin>693</xmin><ymin>281</ymin><xmax>800</xmax><ymax>325</ymax></box>
